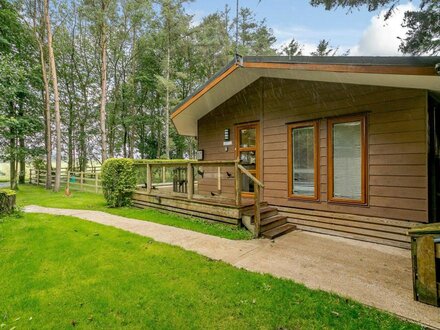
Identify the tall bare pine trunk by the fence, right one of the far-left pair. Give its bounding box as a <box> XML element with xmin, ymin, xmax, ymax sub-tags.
<box><xmin>44</xmin><ymin>0</ymin><xmax>61</xmax><ymax>192</ymax></box>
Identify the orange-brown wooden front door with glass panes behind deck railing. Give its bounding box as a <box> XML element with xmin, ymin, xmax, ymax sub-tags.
<box><xmin>235</xmin><ymin>123</ymin><xmax>259</xmax><ymax>197</ymax></box>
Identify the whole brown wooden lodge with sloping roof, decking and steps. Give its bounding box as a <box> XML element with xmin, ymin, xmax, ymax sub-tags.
<box><xmin>134</xmin><ymin>57</ymin><xmax>440</xmax><ymax>248</ymax></box>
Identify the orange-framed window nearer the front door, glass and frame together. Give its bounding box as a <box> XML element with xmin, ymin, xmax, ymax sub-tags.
<box><xmin>288</xmin><ymin>121</ymin><xmax>319</xmax><ymax>200</ymax></box>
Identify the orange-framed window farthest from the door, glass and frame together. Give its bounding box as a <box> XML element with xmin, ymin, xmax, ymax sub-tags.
<box><xmin>328</xmin><ymin>116</ymin><xmax>367</xmax><ymax>204</ymax></box>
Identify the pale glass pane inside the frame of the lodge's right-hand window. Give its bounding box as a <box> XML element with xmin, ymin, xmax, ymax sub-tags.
<box><xmin>332</xmin><ymin>121</ymin><xmax>362</xmax><ymax>200</ymax></box>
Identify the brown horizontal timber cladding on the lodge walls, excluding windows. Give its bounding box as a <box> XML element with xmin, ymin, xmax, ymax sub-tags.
<box><xmin>198</xmin><ymin>78</ymin><xmax>428</xmax><ymax>247</ymax></box>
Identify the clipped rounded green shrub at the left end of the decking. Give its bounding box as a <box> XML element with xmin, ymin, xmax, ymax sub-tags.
<box><xmin>101</xmin><ymin>158</ymin><xmax>136</xmax><ymax>207</ymax></box>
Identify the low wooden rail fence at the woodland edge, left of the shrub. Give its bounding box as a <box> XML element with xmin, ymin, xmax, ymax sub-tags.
<box><xmin>29</xmin><ymin>168</ymin><xmax>102</xmax><ymax>193</ymax></box>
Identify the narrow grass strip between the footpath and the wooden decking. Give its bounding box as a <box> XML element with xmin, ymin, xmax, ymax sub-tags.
<box><xmin>17</xmin><ymin>185</ymin><xmax>252</xmax><ymax>239</ymax></box>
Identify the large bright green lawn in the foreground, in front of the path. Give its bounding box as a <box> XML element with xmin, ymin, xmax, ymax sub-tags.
<box><xmin>0</xmin><ymin>213</ymin><xmax>419</xmax><ymax>329</ymax></box>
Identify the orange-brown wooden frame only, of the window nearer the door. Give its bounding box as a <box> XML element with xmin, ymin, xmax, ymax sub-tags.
<box><xmin>287</xmin><ymin>120</ymin><xmax>320</xmax><ymax>201</ymax></box>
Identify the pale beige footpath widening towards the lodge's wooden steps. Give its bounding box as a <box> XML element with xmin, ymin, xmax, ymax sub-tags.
<box><xmin>25</xmin><ymin>206</ymin><xmax>440</xmax><ymax>329</ymax></box>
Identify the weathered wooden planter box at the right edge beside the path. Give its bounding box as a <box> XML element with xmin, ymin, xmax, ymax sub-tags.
<box><xmin>408</xmin><ymin>223</ymin><xmax>440</xmax><ymax>306</ymax></box>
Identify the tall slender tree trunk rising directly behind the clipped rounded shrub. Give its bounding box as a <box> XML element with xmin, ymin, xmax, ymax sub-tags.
<box><xmin>100</xmin><ymin>0</ymin><xmax>107</xmax><ymax>164</ymax></box>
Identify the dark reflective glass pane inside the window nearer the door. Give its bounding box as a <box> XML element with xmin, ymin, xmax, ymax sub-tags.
<box><xmin>291</xmin><ymin>126</ymin><xmax>315</xmax><ymax>196</ymax></box>
